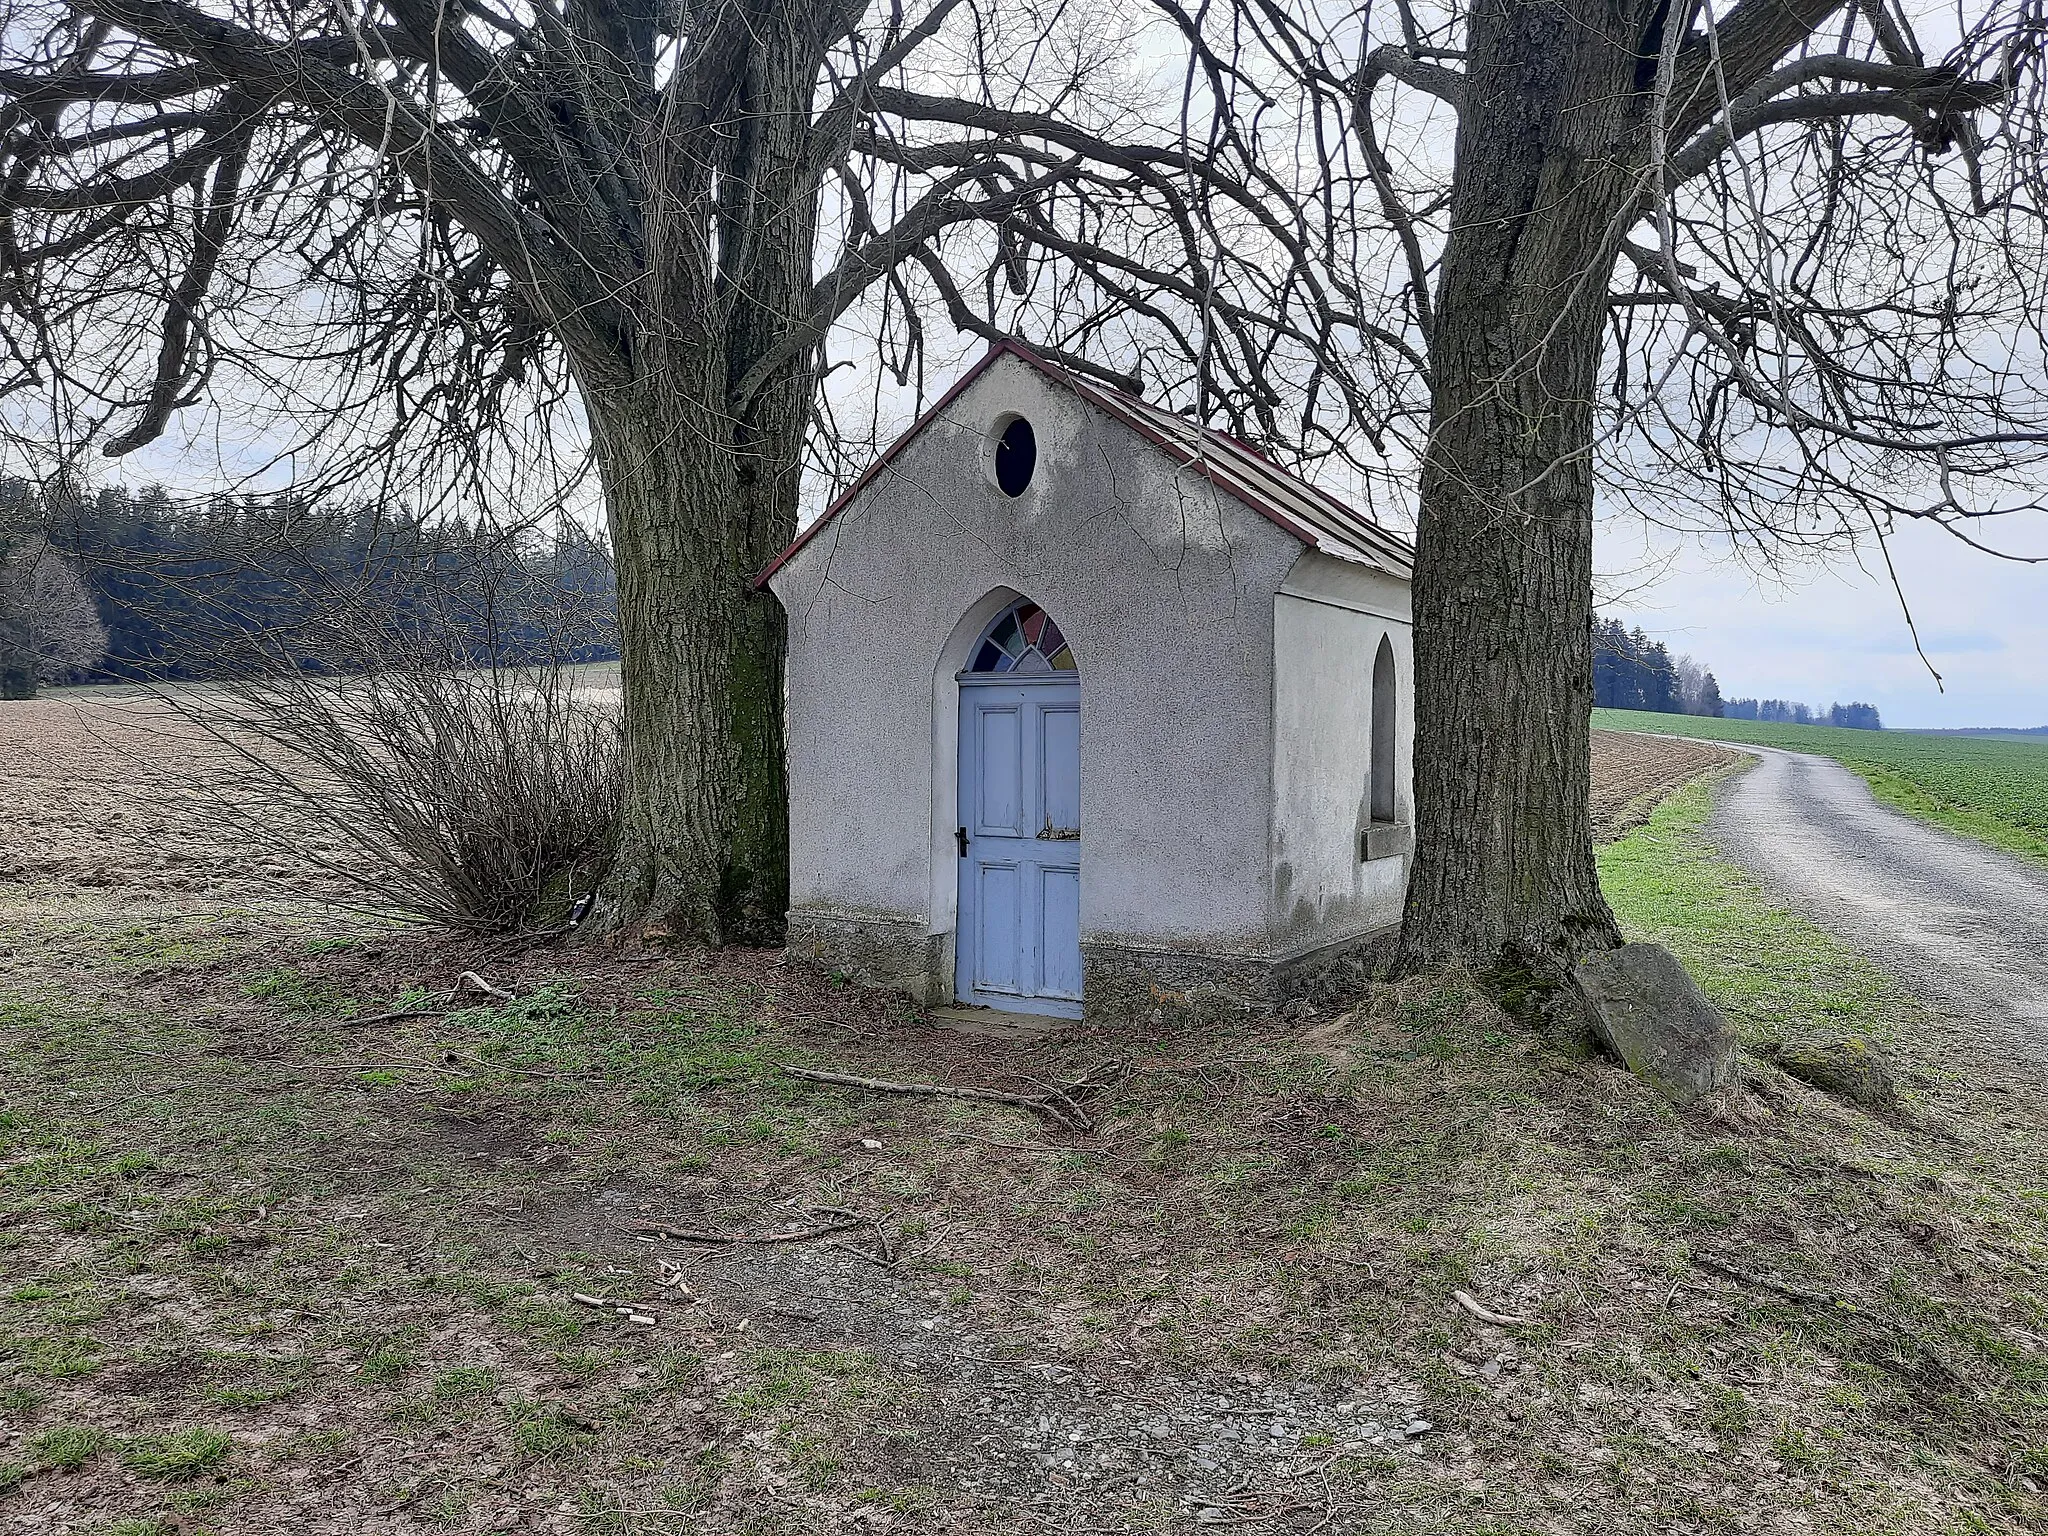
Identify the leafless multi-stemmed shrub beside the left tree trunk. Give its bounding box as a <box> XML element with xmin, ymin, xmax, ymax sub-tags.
<box><xmin>160</xmin><ymin>528</ymin><xmax>623</xmax><ymax>934</ymax></box>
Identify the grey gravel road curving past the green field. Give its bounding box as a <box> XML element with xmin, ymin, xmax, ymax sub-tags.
<box><xmin>1712</xmin><ymin>748</ymin><xmax>2048</xmax><ymax>1061</ymax></box>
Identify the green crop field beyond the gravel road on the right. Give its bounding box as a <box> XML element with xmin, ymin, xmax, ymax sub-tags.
<box><xmin>1593</xmin><ymin>709</ymin><xmax>2048</xmax><ymax>860</ymax></box>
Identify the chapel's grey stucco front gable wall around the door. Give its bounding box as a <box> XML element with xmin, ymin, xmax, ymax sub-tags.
<box><xmin>772</xmin><ymin>356</ymin><xmax>1300</xmax><ymax>1012</ymax></box>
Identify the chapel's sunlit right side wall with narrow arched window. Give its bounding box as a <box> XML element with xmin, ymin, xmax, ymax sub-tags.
<box><xmin>1272</xmin><ymin>549</ymin><xmax>1415</xmax><ymax>963</ymax></box>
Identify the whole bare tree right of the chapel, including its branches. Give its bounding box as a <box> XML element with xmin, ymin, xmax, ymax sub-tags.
<box><xmin>1188</xmin><ymin>0</ymin><xmax>2048</xmax><ymax>979</ymax></box>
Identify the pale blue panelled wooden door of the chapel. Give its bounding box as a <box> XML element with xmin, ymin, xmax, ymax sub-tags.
<box><xmin>954</xmin><ymin>676</ymin><xmax>1081</xmax><ymax>1018</ymax></box>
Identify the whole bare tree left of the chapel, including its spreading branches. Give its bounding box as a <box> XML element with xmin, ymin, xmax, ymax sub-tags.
<box><xmin>0</xmin><ymin>0</ymin><xmax>1384</xmax><ymax>940</ymax></box>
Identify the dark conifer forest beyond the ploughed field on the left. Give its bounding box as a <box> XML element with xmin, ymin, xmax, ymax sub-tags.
<box><xmin>0</xmin><ymin>479</ymin><xmax>618</xmax><ymax>682</ymax></box>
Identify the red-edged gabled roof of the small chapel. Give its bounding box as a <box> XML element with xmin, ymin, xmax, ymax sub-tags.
<box><xmin>754</xmin><ymin>340</ymin><xmax>1415</xmax><ymax>586</ymax></box>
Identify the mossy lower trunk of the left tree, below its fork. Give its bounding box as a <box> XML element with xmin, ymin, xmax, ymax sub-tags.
<box><xmin>586</xmin><ymin>382</ymin><xmax>801</xmax><ymax>944</ymax></box>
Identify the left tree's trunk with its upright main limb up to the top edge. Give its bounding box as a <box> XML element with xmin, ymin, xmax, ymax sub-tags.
<box><xmin>565</xmin><ymin>0</ymin><xmax>831</xmax><ymax>944</ymax></box>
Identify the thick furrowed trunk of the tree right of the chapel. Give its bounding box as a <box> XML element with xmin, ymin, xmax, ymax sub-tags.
<box><xmin>1403</xmin><ymin>0</ymin><xmax>1657</xmax><ymax>979</ymax></box>
